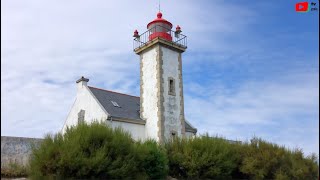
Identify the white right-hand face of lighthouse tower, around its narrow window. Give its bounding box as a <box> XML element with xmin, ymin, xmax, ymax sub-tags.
<box><xmin>161</xmin><ymin>47</ymin><xmax>182</xmax><ymax>139</ymax></box>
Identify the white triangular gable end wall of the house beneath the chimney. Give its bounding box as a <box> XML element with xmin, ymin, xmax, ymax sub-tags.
<box><xmin>62</xmin><ymin>82</ymin><xmax>108</xmax><ymax>133</ymax></box>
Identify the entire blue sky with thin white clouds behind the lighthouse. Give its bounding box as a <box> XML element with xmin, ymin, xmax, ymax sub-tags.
<box><xmin>1</xmin><ymin>0</ymin><xmax>319</xmax><ymax>154</ymax></box>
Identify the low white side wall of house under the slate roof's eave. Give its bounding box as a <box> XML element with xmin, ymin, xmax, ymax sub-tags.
<box><xmin>108</xmin><ymin>121</ymin><xmax>145</xmax><ymax>141</ymax></box>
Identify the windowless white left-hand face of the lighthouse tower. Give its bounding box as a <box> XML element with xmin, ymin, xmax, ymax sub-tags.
<box><xmin>140</xmin><ymin>47</ymin><xmax>159</xmax><ymax>141</ymax></box>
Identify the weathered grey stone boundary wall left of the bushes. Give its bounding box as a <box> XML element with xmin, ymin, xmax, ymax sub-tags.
<box><xmin>1</xmin><ymin>136</ymin><xmax>42</xmax><ymax>168</ymax></box>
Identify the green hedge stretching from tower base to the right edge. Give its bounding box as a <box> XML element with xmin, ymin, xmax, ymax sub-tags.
<box><xmin>166</xmin><ymin>135</ymin><xmax>319</xmax><ymax>180</ymax></box>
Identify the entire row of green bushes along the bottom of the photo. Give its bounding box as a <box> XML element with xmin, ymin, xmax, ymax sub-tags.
<box><xmin>28</xmin><ymin>122</ymin><xmax>318</xmax><ymax>179</ymax></box>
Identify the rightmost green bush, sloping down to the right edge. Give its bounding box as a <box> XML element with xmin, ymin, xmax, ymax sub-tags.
<box><xmin>240</xmin><ymin>138</ymin><xmax>318</xmax><ymax>179</ymax></box>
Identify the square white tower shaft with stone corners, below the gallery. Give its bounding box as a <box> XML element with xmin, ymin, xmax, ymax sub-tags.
<box><xmin>140</xmin><ymin>44</ymin><xmax>185</xmax><ymax>142</ymax></box>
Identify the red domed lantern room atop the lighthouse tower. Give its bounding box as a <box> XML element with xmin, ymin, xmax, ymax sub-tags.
<box><xmin>147</xmin><ymin>12</ymin><xmax>172</xmax><ymax>41</ymax></box>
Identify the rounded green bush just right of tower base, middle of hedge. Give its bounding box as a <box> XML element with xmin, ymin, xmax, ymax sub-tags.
<box><xmin>166</xmin><ymin>135</ymin><xmax>240</xmax><ymax>179</ymax></box>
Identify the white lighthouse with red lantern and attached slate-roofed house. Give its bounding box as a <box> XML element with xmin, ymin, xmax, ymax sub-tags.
<box><xmin>62</xmin><ymin>12</ymin><xmax>197</xmax><ymax>142</ymax></box>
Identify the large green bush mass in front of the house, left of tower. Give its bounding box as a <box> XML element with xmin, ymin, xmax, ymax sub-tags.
<box><xmin>29</xmin><ymin>122</ymin><xmax>167</xmax><ymax>179</ymax></box>
